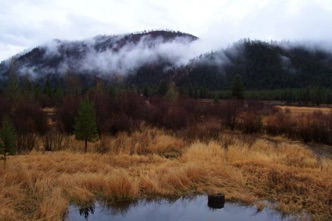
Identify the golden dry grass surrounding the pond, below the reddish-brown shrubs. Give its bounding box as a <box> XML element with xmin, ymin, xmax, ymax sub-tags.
<box><xmin>0</xmin><ymin>131</ymin><xmax>332</xmax><ymax>221</ymax></box>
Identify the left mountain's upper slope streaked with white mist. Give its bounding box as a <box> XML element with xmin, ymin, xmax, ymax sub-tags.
<box><xmin>0</xmin><ymin>31</ymin><xmax>197</xmax><ymax>86</ymax></box>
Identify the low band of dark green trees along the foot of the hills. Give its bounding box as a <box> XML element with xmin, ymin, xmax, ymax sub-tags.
<box><xmin>0</xmin><ymin>72</ymin><xmax>332</xmax><ymax>106</ymax></box>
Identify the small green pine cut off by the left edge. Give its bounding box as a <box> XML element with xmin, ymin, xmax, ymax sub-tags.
<box><xmin>0</xmin><ymin>115</ymin><xmax>17</xmax><ymax>162</ymax></box>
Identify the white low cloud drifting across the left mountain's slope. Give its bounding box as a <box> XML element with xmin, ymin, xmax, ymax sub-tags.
<box><xmin>17</xmin><ymin>32</ymin><xmax>208</xmax><ymax>77</ymax></box>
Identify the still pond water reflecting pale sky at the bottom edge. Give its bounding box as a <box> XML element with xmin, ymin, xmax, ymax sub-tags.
<box><xmin>66</xmin><ymin>196</ymin><xmax>288</xmax><ymax>221</ymax></box>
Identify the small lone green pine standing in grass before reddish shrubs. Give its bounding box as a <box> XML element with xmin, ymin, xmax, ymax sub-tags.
<box><xmin>74</xmin><ymin>99</ymin><xmax>99</xmax><ymax>152</ymax></box>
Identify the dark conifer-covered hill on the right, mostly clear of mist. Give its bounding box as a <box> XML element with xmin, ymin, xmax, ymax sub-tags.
<box><xmin>169</xmin><ymin>39</ymin><xmax>332</xmax><ymax>101</ymax></box>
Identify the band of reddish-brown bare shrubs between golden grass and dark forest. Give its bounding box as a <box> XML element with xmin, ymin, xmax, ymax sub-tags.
<box><xmin>0</xmin><ymin>81</ymin><xmax>332</xmax><ymax>153</ymax></box>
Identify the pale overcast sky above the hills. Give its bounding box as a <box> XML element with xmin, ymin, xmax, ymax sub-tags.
<box><xmin>0</xmin><ymin>0</ymin><xmax>332</xmax><ymax>60</ymax></box>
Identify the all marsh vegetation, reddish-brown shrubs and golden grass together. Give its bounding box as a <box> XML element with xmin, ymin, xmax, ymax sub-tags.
<box><xmin>0</xmin><ymin>85</ymin><xmax>332</xmax><ymax>221</ymax></box>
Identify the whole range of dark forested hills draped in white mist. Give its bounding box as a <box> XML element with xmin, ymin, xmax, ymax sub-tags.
<box><xmin>0</xmin><ymin>31</ymin><xmax>332</xmax><ymax>102</ymax></box>
